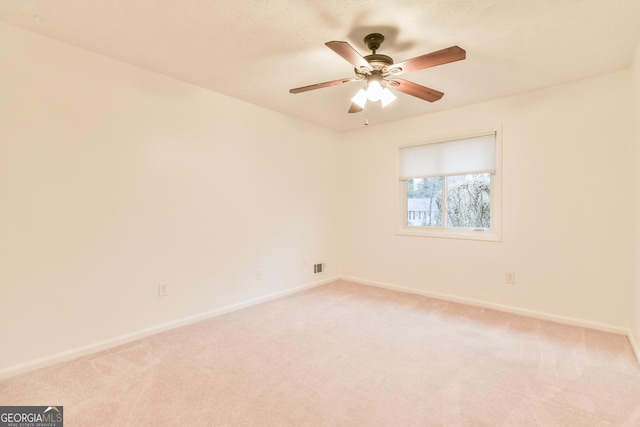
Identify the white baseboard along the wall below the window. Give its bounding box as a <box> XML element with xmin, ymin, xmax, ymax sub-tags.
<box><xmin>341</xmin><ymin>276</ymin><xmax>640</xmax><ymax>342</ymax></box>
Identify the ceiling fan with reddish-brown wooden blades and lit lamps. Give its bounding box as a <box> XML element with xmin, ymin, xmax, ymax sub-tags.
<box><xmin>289</xmin><ymin>33</ymin><xmax>467</xmax><ymax>113</ymax></box>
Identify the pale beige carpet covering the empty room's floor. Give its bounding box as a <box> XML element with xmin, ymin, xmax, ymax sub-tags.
<box><xmin>0</xmin><ymin>281</ymin><xmax>640</xmax><ymax>427</ymax></box>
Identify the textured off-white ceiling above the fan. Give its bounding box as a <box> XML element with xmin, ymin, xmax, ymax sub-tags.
<box><xmin>0</xmin><ymin>0</ymin><xmax>640</xmax><ymax>131</ymax></box>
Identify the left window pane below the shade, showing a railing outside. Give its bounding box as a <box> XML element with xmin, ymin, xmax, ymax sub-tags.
<box><xmin>407</xmin><ymin>177</ymin><xmax>442</xmax><ymax>227</ymax></box>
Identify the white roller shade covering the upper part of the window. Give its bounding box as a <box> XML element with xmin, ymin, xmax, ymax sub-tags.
<box><xmin>400</xmin><ymin>133</ymin><xmax>496</xmax><ymax>180</ymax></box>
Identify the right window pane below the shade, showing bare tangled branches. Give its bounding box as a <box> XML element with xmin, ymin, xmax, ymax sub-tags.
<box><xmin>446</xmin><ymin>173</ymin><xmax>491</xmax><ymax>228</ymax></box>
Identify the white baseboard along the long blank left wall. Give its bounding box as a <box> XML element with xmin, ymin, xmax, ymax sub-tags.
<box><xmin>0</xmin><ymin>276</ymin><xmax>339</xmax><ymax>380</ymax></box>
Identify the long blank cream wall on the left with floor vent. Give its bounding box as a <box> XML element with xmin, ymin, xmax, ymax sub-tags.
<box><xmin>0</xmin><ymin>25</ymin><xmax>340</xmax><ymax>372</ymax></box>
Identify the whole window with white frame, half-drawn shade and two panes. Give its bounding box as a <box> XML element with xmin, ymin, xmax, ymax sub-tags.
<box><xmin>399</xmin><ymin>131</ymin><xmax>500</xmax><ymax>240</ymax></box>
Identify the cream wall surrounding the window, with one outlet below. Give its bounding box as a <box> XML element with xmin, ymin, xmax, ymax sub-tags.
<box><xmin>343</xmin><ymin>71</ymin><xmax>634</xmax><ymax>330</ymax></box>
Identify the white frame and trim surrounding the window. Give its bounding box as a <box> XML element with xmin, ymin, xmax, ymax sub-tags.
<box><xmin>396</xmin><ymin>127</ymin><xmax>502</xmax><ymax>242</ymax></box>
